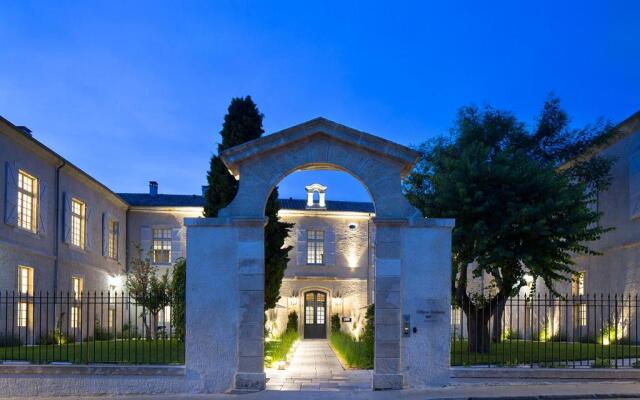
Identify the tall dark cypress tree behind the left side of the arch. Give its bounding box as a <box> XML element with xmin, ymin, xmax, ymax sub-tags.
<box><xmin>204</xmin><ymin>96</ymin><xmax>293</xmax><ymax>309</ymax></box>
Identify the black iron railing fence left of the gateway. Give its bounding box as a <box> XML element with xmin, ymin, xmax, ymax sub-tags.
<box><xmin>0</xmin><ymin>292</ymin><xmax>184</xmax><ymax>364</ymax></box>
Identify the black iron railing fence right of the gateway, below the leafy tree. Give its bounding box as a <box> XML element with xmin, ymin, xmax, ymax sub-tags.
<box><xmin>451</xmin><ymin>294</ymin><xmax>640</xmax><ymax>368</ymax></box>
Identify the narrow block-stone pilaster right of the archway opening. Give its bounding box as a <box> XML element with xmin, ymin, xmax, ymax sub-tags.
<box><xmin>372</xmin><ymin>218</ymin><xmax>407</xmax><ymax>390</ymax></box>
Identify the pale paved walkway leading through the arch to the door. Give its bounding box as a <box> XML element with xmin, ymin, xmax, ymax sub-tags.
<box><xmin>267</xmin><ymin>339</ymin><xmax>371</xmax><ymax>392</ymax></box>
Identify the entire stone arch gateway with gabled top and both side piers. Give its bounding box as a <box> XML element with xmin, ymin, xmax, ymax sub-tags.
<box><xmin>185</xmin><ymin>118</ymin><xmax>453</xmax><ymax>392</ymax></box>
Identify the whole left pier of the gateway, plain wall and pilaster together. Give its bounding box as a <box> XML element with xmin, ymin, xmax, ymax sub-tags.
<box><xmin>185</xmin><ymin>218</ymin><xmax>265</xmax><ymax>393</ymax></box>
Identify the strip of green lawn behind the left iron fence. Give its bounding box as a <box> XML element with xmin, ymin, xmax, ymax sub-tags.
<box><xmin>0</xmin><ymin>339</ymin><xmax>184</xmax><ymax>364</ymax></box>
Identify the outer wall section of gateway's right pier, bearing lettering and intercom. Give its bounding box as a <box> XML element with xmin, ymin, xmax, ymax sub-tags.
<box><xmin>402</xmin><ymin>219</ymin><xmax>454</xmax><ymax>388</ymax></box>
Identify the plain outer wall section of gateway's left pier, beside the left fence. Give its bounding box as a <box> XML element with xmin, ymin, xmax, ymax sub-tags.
<box><xmin>185</xmin><ymin>218</ymin><xmax>239</xmax><ymax>393</ymax></box>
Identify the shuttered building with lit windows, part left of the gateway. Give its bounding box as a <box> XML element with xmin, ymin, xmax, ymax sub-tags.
<box><xmin>0</xmin><ymin>118</ymin><xmax>203</xmax><ymax>340</ymax></box>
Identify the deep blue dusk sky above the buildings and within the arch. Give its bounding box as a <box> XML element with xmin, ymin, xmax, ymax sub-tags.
<box><xmin>0</xmin><ymin>1</ymin><xmax>640</xmax><ymax>200</ymax></box>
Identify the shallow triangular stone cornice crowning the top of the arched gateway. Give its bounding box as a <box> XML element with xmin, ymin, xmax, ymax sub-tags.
<box><xmin>220</xmin><ymin>117</ymin><xmax>420</xmax><ymax>175</ymax></box>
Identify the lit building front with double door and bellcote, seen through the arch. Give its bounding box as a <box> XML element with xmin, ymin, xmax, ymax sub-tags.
<box><xmin>267</xmin><ymin>184</ymin><xmax>375</xmax><ymax>338</ymax></box>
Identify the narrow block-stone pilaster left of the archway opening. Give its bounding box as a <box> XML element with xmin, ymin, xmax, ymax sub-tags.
<box><xmin>234</xmin><ymin>217</ymin><xmax>266</xmax><ymax>390</ymax></box>
